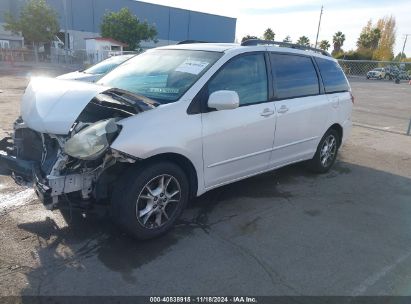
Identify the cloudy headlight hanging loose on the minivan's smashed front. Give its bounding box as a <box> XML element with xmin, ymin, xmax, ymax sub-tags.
<box><xmin>64</xmin><ymin>118</ymin><xmax>119</xmax><ymax>160</ymax></box>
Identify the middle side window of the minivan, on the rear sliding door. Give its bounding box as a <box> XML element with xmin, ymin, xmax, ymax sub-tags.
<box><xmin>271</xmin><ymin>53</ymin><xmax>320</xmax><ymax>99</ymax></box>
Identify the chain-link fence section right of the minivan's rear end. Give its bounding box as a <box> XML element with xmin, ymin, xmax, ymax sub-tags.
<box><xmin>338</xmin><ymin>60</ymin><xmax>411</xmax><ymax>135</ymax></box>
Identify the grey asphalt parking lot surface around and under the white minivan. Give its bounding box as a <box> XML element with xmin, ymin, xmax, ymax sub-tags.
<box><xmin>0</xmin><ymin>70</ymin><xmax>411</xmax><ymax>296</ymax></box>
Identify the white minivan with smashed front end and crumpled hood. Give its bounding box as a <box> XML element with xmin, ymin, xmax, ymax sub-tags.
<box><xmin>0</xmin><ymin>40</ymin><xmax>354</xmax><ymax>239</ymax></box>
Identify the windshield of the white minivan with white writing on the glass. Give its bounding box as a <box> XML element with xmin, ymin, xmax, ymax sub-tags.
<box><xmin>98</xmin><ymin>50</ymin><xmax>222</xmax><ymax>103</ymax></box>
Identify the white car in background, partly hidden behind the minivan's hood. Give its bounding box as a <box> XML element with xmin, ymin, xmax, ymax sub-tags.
<box><xmin>56</xmin><ymin>54</ymin><xmax>136</xmax><ymax>82</ymax></box>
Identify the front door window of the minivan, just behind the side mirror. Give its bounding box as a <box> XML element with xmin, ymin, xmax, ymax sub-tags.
<box><xmin>208</xmin><ymin>54</ymin><xmax>268</xmax><ymax>105</ymax></box>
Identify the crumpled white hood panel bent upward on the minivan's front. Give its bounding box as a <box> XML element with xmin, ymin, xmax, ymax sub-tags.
<box><xmin>21</xmin><ymin>77</ymin><xmax>109</xmax><ymax>135</ymax></box>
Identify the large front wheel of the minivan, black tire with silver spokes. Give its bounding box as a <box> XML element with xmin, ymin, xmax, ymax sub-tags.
<box><xmin>111</xmin><ymin>161</ymin><xmax>189</xmax><ymax>239</ymax></box>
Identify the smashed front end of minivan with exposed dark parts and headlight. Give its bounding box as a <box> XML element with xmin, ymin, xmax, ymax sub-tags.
<box><xmin>0</xmin><ymin>79</ymin><xmax>155</xmax><ymax>209</ymax></box>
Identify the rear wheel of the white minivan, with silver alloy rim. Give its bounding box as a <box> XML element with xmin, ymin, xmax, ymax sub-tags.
<box><xmin>309</xmin><ymin>129</ymin><xmax>340</xmax><ymax>173</ymax></box>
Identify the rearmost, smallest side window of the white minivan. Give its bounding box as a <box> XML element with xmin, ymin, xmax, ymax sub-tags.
<box><xmin>315</xmin><ymin>58</ymin><xmax>349</xmax><ymax>93</ymax></box>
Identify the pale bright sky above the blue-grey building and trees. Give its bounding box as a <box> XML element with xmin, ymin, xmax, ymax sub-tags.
<box><xmin>143</xmin><ymin>0</ymin><xmax>411</xmax><ymax>57</ymax></box>
